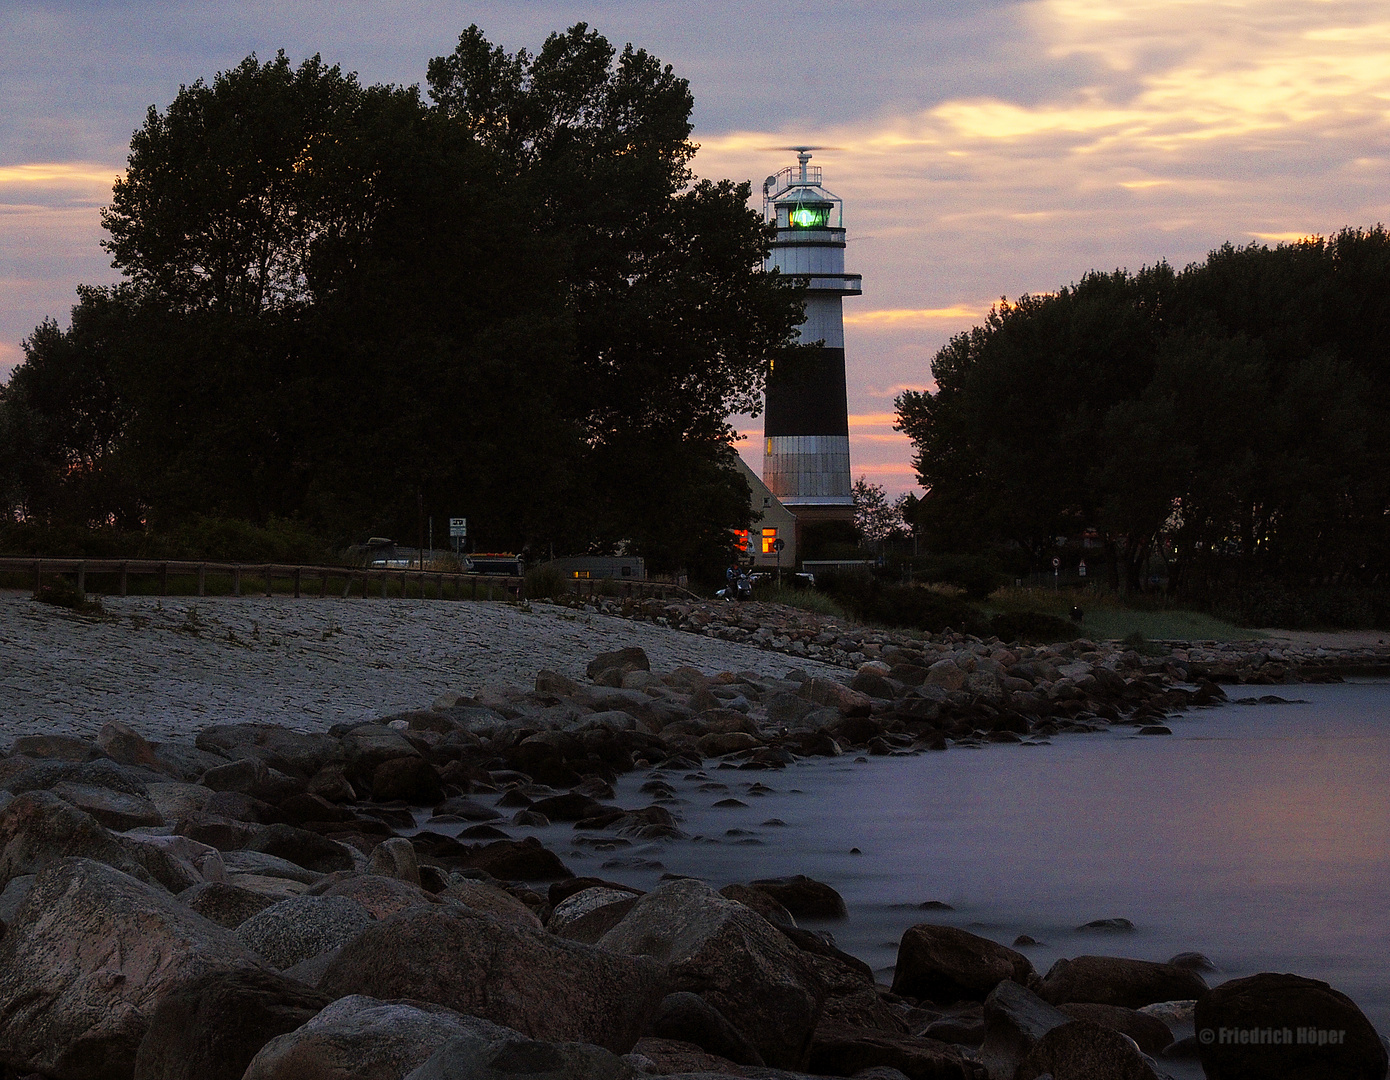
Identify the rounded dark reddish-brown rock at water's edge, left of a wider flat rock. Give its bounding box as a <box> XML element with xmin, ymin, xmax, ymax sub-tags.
<box><xmin>892</xmin><ymin>923</ymin><xmax>1037</xmax><ymax>1005</ymax></box>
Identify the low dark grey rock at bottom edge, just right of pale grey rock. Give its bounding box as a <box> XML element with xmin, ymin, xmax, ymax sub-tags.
<box><xmin>406</xmin><ymin>1034</ymin><xmax>635</xmax><ymax>1080</ymax></box>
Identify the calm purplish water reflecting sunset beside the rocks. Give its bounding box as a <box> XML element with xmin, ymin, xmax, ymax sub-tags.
<box><xmin>444</xmin><ymin>682</ymin><xmax>1390</xmax><ymax>1031</ymax></box>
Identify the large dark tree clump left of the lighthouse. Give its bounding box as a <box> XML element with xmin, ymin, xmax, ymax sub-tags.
<box><xmin>0</xmin><ymin>24</ymin><xmax>802</xmax><ymax>578</ymax></box>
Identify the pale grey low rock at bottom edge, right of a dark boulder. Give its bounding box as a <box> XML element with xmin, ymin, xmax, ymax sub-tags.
<box><xmin>243</xmin><ymin>995</ymin><xmax>514</xmax><ymax>1080</ymax></box>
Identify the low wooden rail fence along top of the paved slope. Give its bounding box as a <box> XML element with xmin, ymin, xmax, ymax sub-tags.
<box><xmin>0</xmin><ymin>556</ymin><xmax>694</xmax><ymax>600</ymax></box>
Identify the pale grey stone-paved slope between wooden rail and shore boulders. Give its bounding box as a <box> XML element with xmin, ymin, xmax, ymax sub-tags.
<box><xmin>0</xmin><ymin>591</ymin><xmax>844</xmax><ymax>749</ymax></box>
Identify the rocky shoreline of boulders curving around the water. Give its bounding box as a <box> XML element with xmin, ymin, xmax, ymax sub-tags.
<box><xmin>0</xmin><ymin>638</ymin><xmax>1387</xmax><ymax>1080</ymax></box>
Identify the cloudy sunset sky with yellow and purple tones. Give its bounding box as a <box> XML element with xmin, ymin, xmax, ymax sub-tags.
<box><xmin>0</xmin><ymin>0</ymin><xmax>1390</xmax><ymax>493</ymax></box>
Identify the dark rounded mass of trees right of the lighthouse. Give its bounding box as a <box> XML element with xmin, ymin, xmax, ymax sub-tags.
<box><xmin>897</xmin><ymin>227</ymin><xmax>1390</xmax><ymax>624</ymax></box>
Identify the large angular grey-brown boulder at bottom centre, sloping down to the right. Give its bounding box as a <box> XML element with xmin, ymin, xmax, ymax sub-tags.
<box><xmin>599</xmin><ymin>878</ymin><xmax>826</xmax><ymax>1069</ymax></box>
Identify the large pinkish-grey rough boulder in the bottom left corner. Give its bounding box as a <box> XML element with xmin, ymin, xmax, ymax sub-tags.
<box><xmin>0</xmin><ymin>859</ymin><xmax>263</xmax><ymax>1080</ymax></box>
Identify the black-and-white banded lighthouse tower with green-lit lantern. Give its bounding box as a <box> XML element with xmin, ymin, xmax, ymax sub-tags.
<box><xmin>763</xmin><ymin>146</ymin><xmax>862</xmax><ymax>528</ymax></box>
